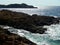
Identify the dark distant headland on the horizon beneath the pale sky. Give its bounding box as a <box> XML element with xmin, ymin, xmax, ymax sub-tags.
<box><xmin>0</xmin><ymin>3</ymin><xmax>37</xmax><ymax>8</ymax></box>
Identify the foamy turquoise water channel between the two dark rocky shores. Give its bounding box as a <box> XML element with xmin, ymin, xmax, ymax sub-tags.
<box><xmin>2</xmin><ymin>24</ymin><xmax>60</xmax><ymax>45</ymax></box>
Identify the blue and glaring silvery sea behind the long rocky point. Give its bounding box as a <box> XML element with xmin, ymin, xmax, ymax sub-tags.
<box><xmin>0</xmin><ymin>6</ymin><xmax>60</xmax><ymax>16</ymax></box>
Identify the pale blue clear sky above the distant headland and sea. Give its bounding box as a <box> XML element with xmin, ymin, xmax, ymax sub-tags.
<box><xmin>0</xmin><ymin>0</ymin><xmax>60</xmax><ymax>7</ymax></box>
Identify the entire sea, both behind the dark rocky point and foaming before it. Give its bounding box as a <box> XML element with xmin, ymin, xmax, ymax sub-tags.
<box><xmin>0</xmin><ymin>6</ymin><xmax>60</xmax><ymax>45</ymax></box>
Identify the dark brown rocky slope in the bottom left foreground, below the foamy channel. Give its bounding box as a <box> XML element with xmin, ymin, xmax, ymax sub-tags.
<box><xmin>0</xmin><ymin>28</ymin><xmax>36</xmax><ymax>45</ymax></box>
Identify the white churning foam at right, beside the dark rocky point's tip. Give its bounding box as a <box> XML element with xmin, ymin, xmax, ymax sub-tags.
<box><xmin>44</xmin><ymin>24</ymin><xmax>60</xmax><ymax>40</ymax></box>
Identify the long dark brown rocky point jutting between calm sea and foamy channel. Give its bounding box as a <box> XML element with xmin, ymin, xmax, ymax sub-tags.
<box><xmin>0</xmin><ymin>10</ymin><xmax>59</xmax><ymax>34</ymax></box>
